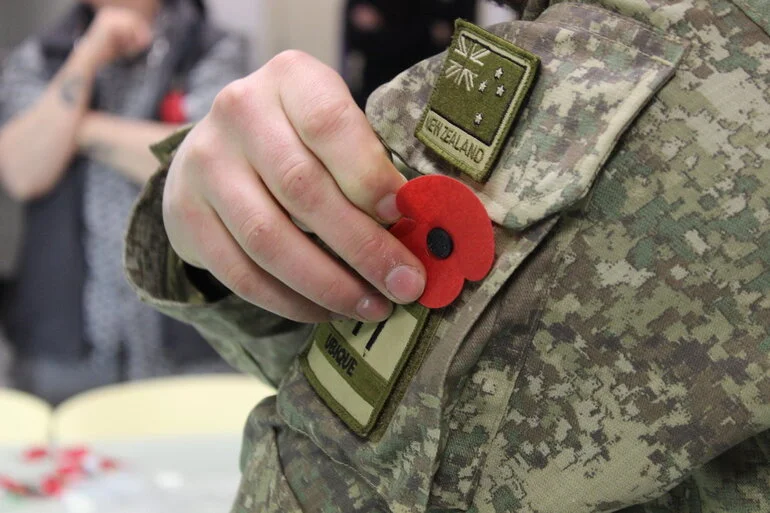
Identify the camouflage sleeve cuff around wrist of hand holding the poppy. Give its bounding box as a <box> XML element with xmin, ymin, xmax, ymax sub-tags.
<box><xmin>124</xmin><ymin>129</ymin><xmax>312</xmax><ymax>386</ymax></box>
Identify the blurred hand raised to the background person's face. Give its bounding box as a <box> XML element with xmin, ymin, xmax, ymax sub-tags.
<box><xmin>79</xmin><ymin>7</ymin><xmax>152</xmax><ymax>69</ymax></box>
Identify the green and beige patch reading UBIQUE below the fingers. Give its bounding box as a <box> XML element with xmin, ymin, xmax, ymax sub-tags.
<box><xmin>300</xmin><ymin>303</ymin><xmax>430</xmax><ymax>436</ymax></box>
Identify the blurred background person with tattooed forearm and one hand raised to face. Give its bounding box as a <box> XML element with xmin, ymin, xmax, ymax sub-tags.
<box><xmin>0</xmin><ymin>0</ymin><xmax>246</xmax><ymax>402</ymax></box>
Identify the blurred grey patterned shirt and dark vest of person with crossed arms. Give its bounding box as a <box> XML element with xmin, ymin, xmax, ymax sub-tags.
<box><xmin>0</xmin><ymin>0</ymin><xmax>245</xmax><ymax>403</ymax></box>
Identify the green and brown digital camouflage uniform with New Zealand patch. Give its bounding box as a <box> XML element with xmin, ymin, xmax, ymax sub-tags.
<box><xmin>126</xmin><ymin>0</ymin><xmax>770</xmax><ymax>513</ymax></box>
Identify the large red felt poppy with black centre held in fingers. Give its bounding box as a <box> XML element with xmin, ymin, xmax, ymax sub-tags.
<box><xmin>390</xmin><ymin>175</ymin><xmax>495</xmax><ymax>308</ymax></box>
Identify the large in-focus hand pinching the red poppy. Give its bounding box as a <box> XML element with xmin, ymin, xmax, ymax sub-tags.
<box><xmin>163</xmin><ymin>51</ymin><xmax>425</xmax><ymax>322</ymax></box>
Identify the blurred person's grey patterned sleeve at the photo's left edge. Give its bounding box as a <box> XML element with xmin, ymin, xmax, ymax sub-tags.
<box><xmin>0</xmin><ymin>39</ymin><xmax>48</xmax><ymax>125</ymax></box>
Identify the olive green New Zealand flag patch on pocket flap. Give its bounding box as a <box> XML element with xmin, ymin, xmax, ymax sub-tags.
<box><xmin>415</xmin><ymin>20</ymin><xmax>540</xmax><ymax>182</ymax></box>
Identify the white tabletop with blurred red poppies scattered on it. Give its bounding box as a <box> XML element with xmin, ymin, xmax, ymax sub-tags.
<box><xmin>0</xmin><ymin>436</ymin><xmax>241</xmax><ymax>513</ymax></box>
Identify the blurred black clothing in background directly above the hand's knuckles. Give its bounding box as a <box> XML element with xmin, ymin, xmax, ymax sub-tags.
<box><xmin>344</xmin><ymin>0</ymin><xmax>476</xmax><ymax>108</ymax></box>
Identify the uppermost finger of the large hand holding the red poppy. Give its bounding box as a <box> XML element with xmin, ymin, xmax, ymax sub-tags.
<box><xmin>278</xmin><ymin>52</ymin><xmax>406</xmax><ymax>223</ymax></box>
